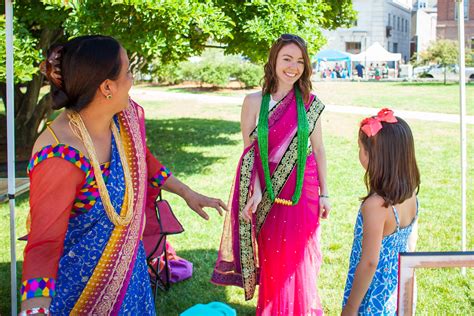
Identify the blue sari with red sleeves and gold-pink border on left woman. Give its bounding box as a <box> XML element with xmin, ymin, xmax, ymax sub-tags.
<box><xmin>21</xmin><ymin>101</ymin><xmax>170</xmax><ymax>315</ymax></box>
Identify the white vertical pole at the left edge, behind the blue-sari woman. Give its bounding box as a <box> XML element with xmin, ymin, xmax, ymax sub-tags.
<box><xmin>5</xmin><ymin>0</ymin><xmax>17</xmax><ymax>316</ymax></box>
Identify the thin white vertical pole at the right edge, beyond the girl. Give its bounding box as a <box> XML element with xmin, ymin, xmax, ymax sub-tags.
<box><xmin>456</xmin><ymin>0</ymin><xmax>467</xmax><ymax>276</ymax></box>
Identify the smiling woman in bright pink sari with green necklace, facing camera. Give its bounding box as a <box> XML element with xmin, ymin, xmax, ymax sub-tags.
<box><xmin>212</xmin><ymin>34</ymin><xmax>330</xmax><ymax>315</ymax></box>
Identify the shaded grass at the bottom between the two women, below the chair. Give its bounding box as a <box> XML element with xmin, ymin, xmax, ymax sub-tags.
<box><xmin>156</xmin><ymin>249</ymin><xmax>255</xmax><ymax>316</ymax></box>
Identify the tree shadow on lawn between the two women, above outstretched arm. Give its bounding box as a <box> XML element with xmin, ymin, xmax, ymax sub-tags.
<box><xmin>146</xmin><ymin>118</ymin><xmax>240</xmax><ymax>175</ymax></box>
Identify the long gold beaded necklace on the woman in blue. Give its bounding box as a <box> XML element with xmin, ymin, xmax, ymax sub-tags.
<box><xmin>67</xmin><ymin>111</ymin><xmax>134</xmax><ymax>226</ymax></box>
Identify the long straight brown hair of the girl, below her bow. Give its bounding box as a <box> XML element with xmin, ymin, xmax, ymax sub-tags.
<box><xmin>359</xmin><ymin>117</ymin><xmax>420</xmax><ymax>207</ymax></box>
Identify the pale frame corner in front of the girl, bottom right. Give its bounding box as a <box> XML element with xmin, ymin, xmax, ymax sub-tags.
<box><xmin>398</xmin><ymin>251</ymin><xmax>474</xmax><ymax>316</ymax></box>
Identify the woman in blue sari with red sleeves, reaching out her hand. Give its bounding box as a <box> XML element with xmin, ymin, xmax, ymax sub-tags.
<box><xmin>21</xmin><ymin>36</ymin><xmax>225</xmax><ymax>315</ymax></box>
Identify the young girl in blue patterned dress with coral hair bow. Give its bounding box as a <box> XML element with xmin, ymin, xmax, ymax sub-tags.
<box><xmin>342</xmin><ymin>109</ymin><xmax>420</xmax><ymax>315</ymax></box>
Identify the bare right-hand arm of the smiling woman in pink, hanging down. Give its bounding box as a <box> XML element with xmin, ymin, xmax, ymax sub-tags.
<box><xmin>310</xmin><ymin>118</ymin><xmax>331</xmax><ymax>218</ymax></box>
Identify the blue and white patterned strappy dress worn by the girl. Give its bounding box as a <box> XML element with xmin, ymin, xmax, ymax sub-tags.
<box><xmin>342</xmin><ymin>201</ymin><xmax>418</xmax><ymax>315</ymax></box>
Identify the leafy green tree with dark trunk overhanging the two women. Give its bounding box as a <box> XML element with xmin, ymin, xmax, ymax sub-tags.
<box><xmin>0</xmin><ymin>0</ymin><xmax>355</xmax><ymax>159</ymax></box>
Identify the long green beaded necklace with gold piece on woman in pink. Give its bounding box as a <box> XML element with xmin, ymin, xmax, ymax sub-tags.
<box><xmin>257</xmin><ymin>85</ymin><xmax>309</xmax><ymax>205</ymax></box>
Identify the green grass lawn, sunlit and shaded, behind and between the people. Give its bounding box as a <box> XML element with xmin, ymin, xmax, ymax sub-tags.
<box><xmin>0</xmin><ymin>83</ymin><xmax>474</xmax><ymax>315</ymax></box>
